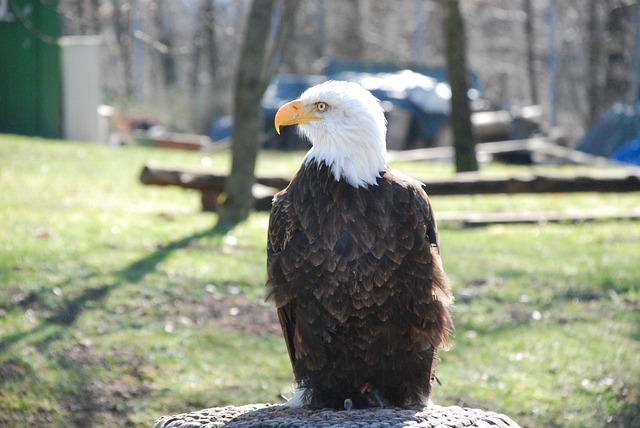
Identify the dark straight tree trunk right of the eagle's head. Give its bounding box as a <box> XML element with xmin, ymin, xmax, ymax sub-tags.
<box><xmin>444</xmin><ymin>0</ymin><xmax>478</xmax><ymax>172</ymax></box>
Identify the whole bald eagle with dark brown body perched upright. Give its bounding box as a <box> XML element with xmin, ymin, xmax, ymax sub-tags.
<box><xmin>266</xmin><ymin>81</ymin><xmax>453</xmax><ymax>408</ymax></box>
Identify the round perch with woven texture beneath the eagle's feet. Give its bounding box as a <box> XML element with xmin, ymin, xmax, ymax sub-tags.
<box><xmin>154</xmin><ymin>404</ymin><xmax>520</xmax><ymax>428</ymax></box>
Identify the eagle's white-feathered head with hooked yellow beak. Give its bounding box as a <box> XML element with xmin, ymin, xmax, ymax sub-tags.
<box><xmin>275</xmin><ymin>80</ymin><xmax>387</xmax><ymax>187</ymax></box>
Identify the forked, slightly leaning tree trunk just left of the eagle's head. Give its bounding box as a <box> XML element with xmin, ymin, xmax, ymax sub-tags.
<box><xmin>218</xmin><ymin>0</ymin><xmax>298</xmax><ymax>223</ymax></box>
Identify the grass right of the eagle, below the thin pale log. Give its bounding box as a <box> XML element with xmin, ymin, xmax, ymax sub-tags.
<box><xmin>435</xmin><ymin>222</ymin><xmax>640</xmax><ymax>427</ymax></box>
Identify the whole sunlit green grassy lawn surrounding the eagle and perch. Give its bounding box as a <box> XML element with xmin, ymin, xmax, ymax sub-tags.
<box><xmin>0</xmin><ymin>136</ymin><xmax>640</xmax><ymax>427</ymax></box>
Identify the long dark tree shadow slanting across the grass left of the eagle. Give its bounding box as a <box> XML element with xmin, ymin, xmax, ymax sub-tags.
<box><xmin>0</xmin><ymin>223</ymin><xmax>238</xmax><ymax>351</ymax></box>
